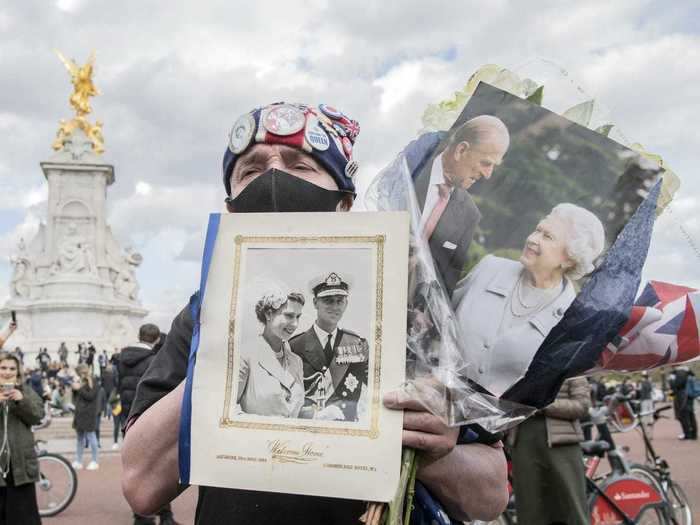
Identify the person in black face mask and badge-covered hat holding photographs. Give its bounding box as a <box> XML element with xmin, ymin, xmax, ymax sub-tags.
<box><xmin>122</xmin><ymin>104</ymin><xmax>508</xmax><ymax>525</ymax></box>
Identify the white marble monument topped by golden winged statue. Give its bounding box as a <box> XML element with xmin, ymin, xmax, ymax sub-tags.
<box><xmin>0</xmin><ymin>51</ymin><xmax>147</xmax><ymax>358</ymax></box>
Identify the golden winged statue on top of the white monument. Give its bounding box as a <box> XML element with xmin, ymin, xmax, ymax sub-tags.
<box><xmin>53</xmin><ymin>51</ymin><xmax>104</xmax><ymax>154</ymax></box>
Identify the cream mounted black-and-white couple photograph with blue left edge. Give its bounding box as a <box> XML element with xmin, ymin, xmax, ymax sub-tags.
<box><xmin>180</xmin><ymin>212</ymin><xmax>408</xmax><ymax>501</ymax></box>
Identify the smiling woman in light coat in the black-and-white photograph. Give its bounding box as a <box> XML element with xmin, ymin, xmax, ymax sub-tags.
<box><xmin>236</xmin><ymin>289</ymin><xmax>305</xmax><ymax>418</ymax></box>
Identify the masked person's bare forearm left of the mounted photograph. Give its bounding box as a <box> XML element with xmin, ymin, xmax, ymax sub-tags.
<box><xmin>122</xmin><ymin>381</ymin><xmax>185</xmax><ymax>514</ymax></box>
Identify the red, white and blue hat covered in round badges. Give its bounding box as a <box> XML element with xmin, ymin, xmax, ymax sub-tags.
<box><xmin>223</xmin><ymin>102</ymin><xmax>360</xmax><ymax>196</ymax></box>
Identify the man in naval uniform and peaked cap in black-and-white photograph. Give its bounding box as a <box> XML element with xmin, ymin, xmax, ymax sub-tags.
<box><xmin>289</xmin><ymin>272</ymin><xmax>369</xmax><ymax>421</ymax></box>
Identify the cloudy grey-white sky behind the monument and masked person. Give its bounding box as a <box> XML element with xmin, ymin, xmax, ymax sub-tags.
<box><xmin>0</xmin><ymin>0</ymin><xmax>700</xmax><ymax>327</ymax></box>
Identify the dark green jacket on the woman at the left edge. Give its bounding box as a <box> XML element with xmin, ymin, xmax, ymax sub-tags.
<box><xmin>0</xmin><ymin>387</ymin><xmax>44</xmax><ymax>487</ymax></box>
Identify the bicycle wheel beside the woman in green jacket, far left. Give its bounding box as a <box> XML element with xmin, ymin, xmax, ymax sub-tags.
<box><xmin>36</xmin><ymin>453</ymin><xmax>78</xmax><ymax>517</ymax></box>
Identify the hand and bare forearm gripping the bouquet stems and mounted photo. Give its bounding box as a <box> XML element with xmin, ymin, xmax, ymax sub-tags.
<box><xmin>384</xmin><ymin>391</ymin><xmax>508</xmax><ymax>521</ymax></box>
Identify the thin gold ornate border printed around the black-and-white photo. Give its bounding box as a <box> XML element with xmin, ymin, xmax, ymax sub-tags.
<box><xmin>219</xmin><ymin>235</ymin><xmax>386</xmax><ymax>439</ymax></box>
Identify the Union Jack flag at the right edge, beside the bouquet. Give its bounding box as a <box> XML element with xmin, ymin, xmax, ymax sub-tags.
<box><xmin>599</xmin><ymin>281</ymin><xmax>700</xmax><ymax>371</ymax></box>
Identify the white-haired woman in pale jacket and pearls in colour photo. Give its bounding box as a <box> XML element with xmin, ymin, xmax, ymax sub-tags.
<box><xmin>452</xmin><ymin>203</ymin><xmax>605</xmax><ymax>395</ymax></box>
